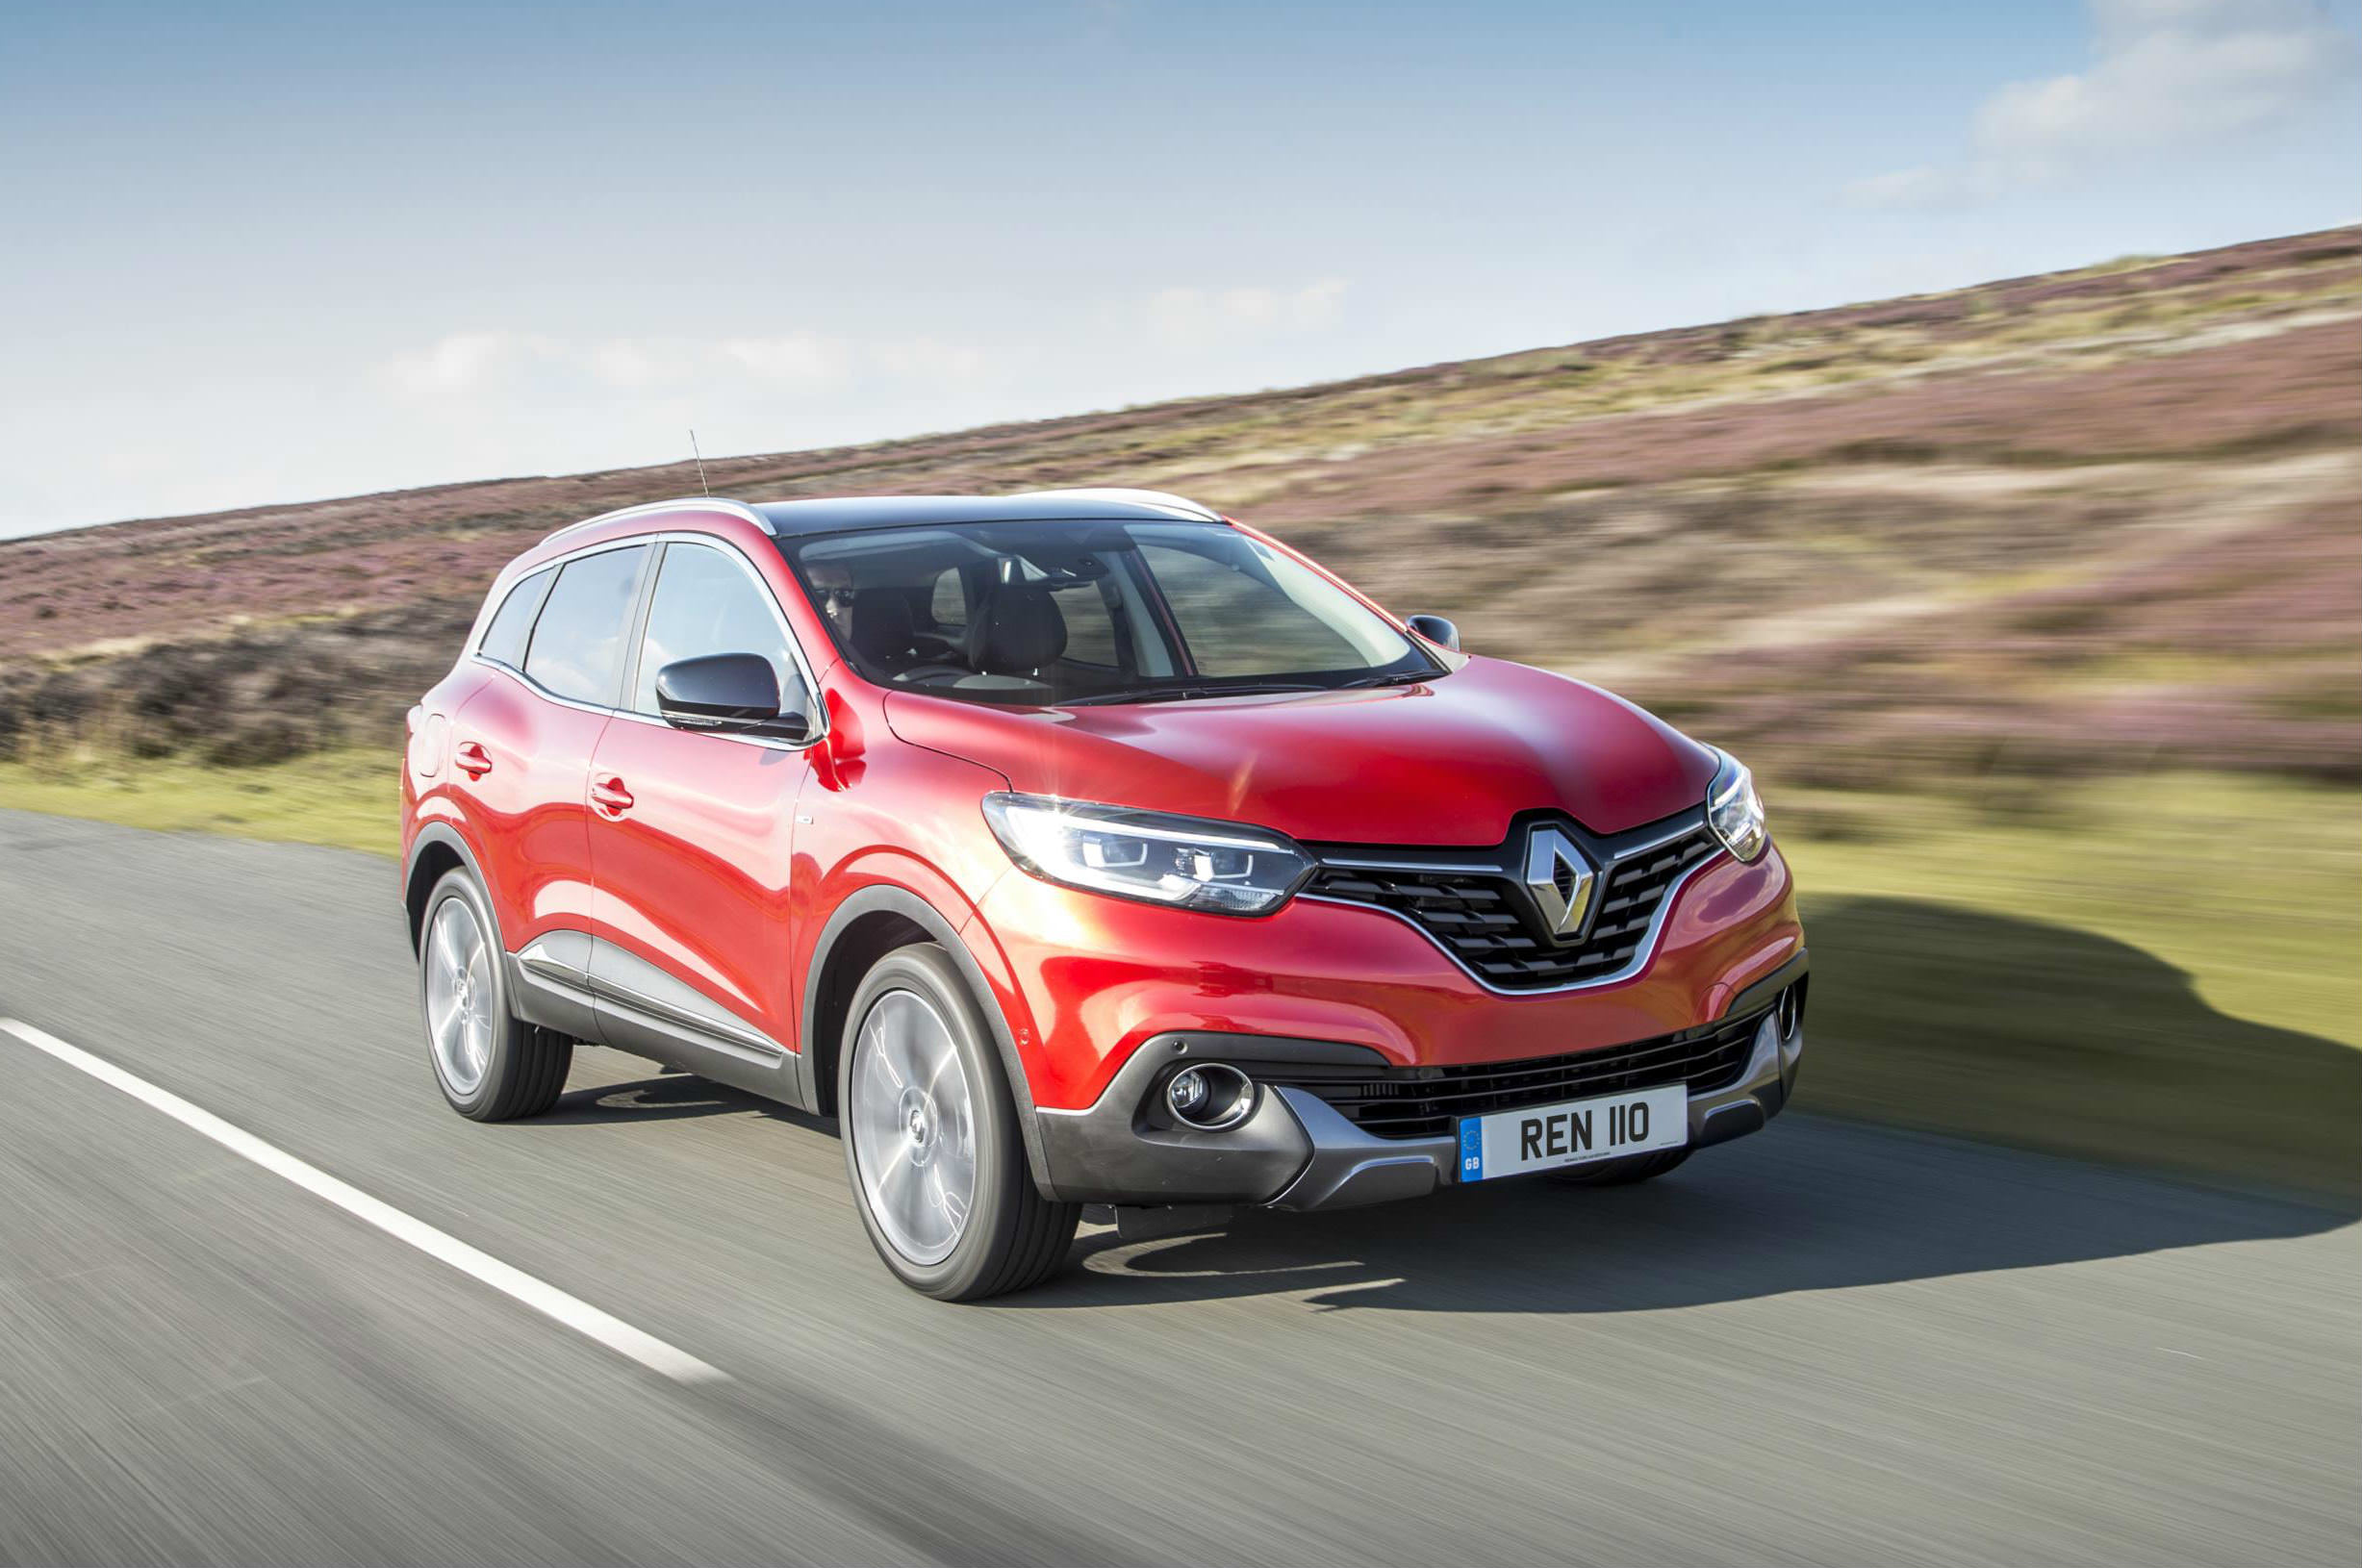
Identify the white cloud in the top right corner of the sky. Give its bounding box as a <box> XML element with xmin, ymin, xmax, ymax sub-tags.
<box><xmin>1844</xmin><ymin>0</ymin><xmax>2362</xmax><ymax>206</ymax></box>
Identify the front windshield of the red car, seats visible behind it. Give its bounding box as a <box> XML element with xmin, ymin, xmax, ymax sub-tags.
<box><xmin>782</xmin><ymin>522</ymin><xmax>1441</xmax><ymax>704</ymax></box>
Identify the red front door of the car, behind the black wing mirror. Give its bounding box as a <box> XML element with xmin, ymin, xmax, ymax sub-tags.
<box><xmin>591</xmin><ymin>539</ymin><xmax>820</xmax><ymax>1098</ymax></box>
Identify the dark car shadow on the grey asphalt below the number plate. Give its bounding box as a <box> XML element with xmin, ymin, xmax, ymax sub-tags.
<box><xmin>1020</xmin><ymin>1117</ymin><xmax>2357</xmax><ymax>1313</ymax></box>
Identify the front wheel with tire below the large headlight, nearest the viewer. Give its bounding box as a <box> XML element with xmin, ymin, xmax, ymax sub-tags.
<box><xmin>836</xmin><ymin>942</ymin><xmax>1081</xmax><ymax>1302</ymax></box>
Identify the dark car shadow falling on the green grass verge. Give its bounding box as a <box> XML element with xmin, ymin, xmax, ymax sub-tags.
<box><xmin>1805</xmin><ymin>898</ymin><xmax>2362</xmax><ymax>1198</ymax></box>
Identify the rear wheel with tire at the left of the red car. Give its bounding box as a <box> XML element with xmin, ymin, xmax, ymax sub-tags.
<box><xmin>419</xmin><ymin>872</ymin><xmax>574</xmax><ymax>1122</ymax></box>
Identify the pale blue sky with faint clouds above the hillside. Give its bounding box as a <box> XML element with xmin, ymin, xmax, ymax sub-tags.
<box><xmin>0</xmin><ymin>0</ymin><xmax>2362</xmax><ymax>536</ymax></box>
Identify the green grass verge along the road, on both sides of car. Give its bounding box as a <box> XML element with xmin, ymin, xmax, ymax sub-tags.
<box><xmin>0</xmin><ymin>751</ymin><xmax>2362</xmax><ymax>1202</ymax></box>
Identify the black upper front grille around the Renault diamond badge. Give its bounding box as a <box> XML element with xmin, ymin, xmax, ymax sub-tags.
<box><xmin>1304</xmin><ymin>822</ymin><xmax>1714</xmax><ymax>992</ymax></box>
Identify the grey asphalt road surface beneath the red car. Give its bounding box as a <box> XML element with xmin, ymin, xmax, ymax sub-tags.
<box><xmin>0</xmin><ymin>812</ymin><xmax>2362</xmax><ymax>1568</ymax></box>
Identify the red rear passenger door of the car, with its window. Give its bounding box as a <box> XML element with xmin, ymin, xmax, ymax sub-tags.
<box><xmin>451</xmin><ymin>544</ymin><xmax>652</xmax><ymax>1037</ymax></box>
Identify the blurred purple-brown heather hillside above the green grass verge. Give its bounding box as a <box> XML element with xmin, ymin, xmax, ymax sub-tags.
<box><xmin>0</xmin><ymin>229</ymin><xmax>2362</xmax><ymax>789</ymax></box>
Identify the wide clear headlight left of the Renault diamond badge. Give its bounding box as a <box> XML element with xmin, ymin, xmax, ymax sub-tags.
<box><xmin>985</xmin><ymin>791</ymin><xmax>1313</xmax><ymax>914</ymax></box>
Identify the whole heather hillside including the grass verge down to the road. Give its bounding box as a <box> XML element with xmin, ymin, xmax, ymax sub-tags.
<box><xmin>0</xmin><ymin>229</ymin><xmax>2362</xmax><ymax>1200</ymax></box>
